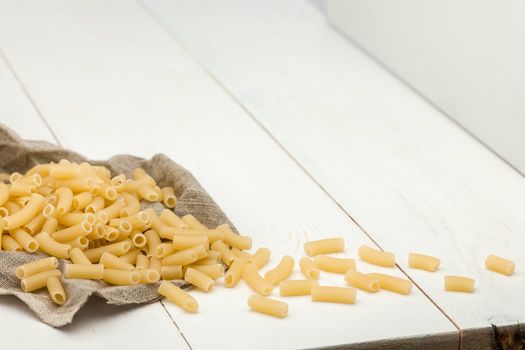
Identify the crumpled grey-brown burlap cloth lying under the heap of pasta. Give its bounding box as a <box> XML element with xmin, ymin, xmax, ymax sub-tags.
<box><xmin>0</xmin><ymin>124</ymin><xmax>234</xmax><ymax>327</ymax></box>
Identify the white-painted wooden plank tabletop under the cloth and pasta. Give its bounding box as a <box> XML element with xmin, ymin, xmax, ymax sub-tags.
<box><xmin>0</xmin><ymin>0</ymin><xmax>525</xmax><ymax>349</ymax></box>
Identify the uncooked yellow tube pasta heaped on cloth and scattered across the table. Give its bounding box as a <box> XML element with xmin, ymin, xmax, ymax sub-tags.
<box><xmin>0</xmin><ymin>160</ymin><xmax>514</xmax><ymax>318</ymax></box>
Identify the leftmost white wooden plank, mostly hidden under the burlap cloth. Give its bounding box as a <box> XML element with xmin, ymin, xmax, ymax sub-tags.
<box><xmin>0</xmin><ymin>38</ymin><xmax>188</xmax><ymax>350</ymax></box>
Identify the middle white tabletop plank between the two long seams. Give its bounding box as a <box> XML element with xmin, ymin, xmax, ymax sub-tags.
<box><xmin>0</xmin><ymin>0</ymin><xmax>455</xmax><ymax>349</ymax></box>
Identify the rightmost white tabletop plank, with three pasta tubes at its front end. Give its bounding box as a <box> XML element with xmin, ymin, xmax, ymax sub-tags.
<box><xmin>146</xmin><ymin>0</ymin><xmax>525</xmax><ymax>328</ymax></box>
